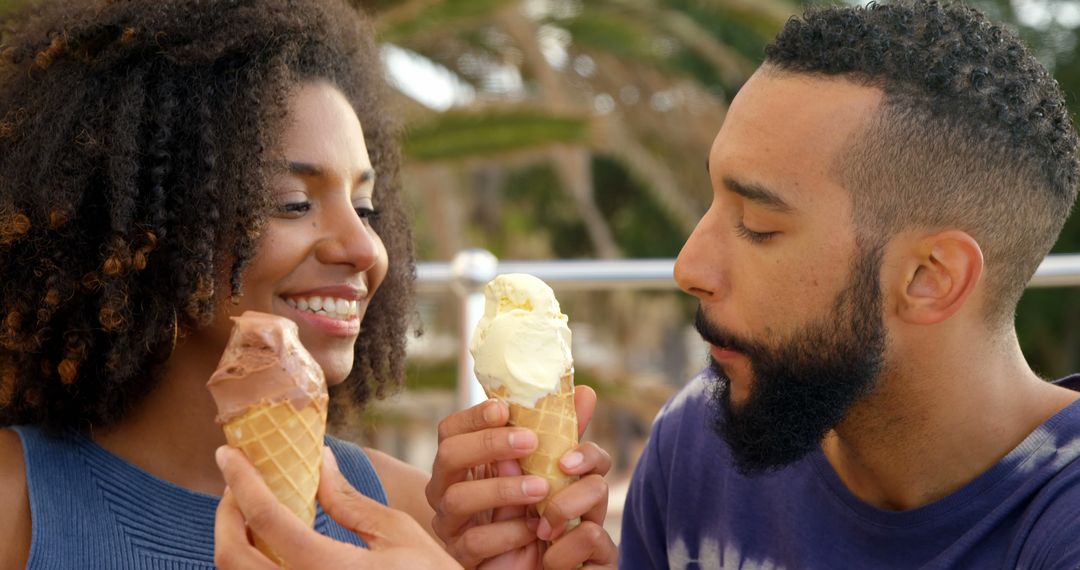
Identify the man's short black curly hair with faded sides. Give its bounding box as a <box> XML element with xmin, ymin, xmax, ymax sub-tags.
<box><xmin>766</xmin><ymin>0</ymin><xmax>1080</xmax><ymax>325</ymax></box>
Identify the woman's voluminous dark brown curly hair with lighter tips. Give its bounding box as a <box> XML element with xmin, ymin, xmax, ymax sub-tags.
<box><xmin>0</xmin><ymin>0</ymin><xmax>415</xmax><ymax>430</ymax></box>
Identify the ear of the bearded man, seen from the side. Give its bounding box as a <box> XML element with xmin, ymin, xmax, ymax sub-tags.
<box><xmin>896</xmin><ymin>230</ymin><xmax>983</xmax><ymax>325</ymax></box>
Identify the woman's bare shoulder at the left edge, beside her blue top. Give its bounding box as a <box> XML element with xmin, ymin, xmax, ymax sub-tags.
<box><xmin>0</xmin><ymin>428</ymin><xmax>30</xmax><ymax>570</ymax></box>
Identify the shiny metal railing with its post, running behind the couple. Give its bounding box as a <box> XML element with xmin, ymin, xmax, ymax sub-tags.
<box><xmin>417</xmin><ymin>249</ymin><xmax>1080</xmax><ymax>407</ymax></box>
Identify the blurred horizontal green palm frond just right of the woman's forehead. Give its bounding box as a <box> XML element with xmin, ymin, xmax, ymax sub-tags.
<box><xmin>403</xmin><ymin>110</ymin><xmax>589</xmax><ymax>161</ymax></box>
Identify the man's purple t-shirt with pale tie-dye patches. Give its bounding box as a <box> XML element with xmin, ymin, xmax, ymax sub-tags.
<box><xmin>619</xmin><ymin>376</ymin><xmax>1080</xmax><ymax>570</ymax></box>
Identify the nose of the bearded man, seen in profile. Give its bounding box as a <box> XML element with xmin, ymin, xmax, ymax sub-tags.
<box><xmin>675</xmin><ymin>208</ymin><xmax>727</xmax><ymax>301</ymax></box>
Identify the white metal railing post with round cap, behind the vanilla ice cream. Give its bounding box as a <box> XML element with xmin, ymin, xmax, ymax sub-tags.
<box><xmin>450</xmin><ymin>248</ymin><xmax>499</xmax><ymax>409</ymax></box>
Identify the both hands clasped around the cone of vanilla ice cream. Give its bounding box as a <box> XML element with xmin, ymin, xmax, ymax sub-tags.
<box><xmin>427</xmin><ymin>386</ymin><xmax>617</xmax><ymax>569</ymax></box>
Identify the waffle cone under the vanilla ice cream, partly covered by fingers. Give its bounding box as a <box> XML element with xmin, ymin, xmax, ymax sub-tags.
<box><xmin>488</xmin><ymin>371</ymin><xmax>578</xmax><ymax>515</ymax></box>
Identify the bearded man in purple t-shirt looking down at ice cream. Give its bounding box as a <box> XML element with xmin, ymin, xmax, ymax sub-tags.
<box><xmin>620</xmin><ymin>1</ymin><xmax>1080</xmax><ymax>569</ymax></box>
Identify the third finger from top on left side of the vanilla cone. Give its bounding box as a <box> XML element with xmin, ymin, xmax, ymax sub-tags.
<box><xmin>433</xmin><ymin>475</ymin><xmax>550</xmax><ymax>538</ymax></box>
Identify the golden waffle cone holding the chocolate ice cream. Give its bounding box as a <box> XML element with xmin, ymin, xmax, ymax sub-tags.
<box><xmin>217</xmin><ymin>395</ymin><xmax>327</xmax><ymax>566</ymax></box>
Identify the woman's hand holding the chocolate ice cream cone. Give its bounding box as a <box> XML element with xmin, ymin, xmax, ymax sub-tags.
<box><xmin>214</xmin><ymin>446</ymin><xmax>461</xmax><ymax>570</ymax></box>
